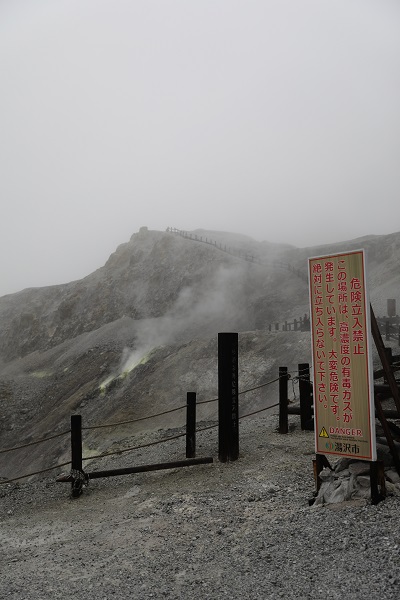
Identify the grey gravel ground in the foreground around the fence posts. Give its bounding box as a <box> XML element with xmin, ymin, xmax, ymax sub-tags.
<box><xmin>0</xmin><ymin>414</ymin><xmax>400</xmax><ymax>600</ymax></box>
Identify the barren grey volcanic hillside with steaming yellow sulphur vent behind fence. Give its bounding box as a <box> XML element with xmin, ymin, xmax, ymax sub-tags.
<box><xmin>0</xmin><ymin>227</ymin><xmax>400</xmax><ymax>478</ymax></box>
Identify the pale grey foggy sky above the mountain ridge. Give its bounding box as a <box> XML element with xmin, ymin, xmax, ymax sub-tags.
<box><xmin>0</xmin><ymin>0</ymin><xmax>400</xmax><ymax>295</ymax></box>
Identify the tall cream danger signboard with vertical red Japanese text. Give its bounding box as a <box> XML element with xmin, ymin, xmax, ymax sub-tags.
<box><xmin>309</xmin><ymin>250</ymin><xmax>376</xmax><ymax>460</ymax></box>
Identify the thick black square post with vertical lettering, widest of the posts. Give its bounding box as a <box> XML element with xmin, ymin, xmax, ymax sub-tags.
<box><xmin>218</xmin><ymin>333</ymin><xmax>239</xmax><ymax>462</ymax></box>
